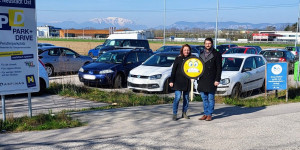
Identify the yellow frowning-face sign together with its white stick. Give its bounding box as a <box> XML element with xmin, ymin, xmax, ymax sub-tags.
<box><xmin>182</xmin><ymin>56</ymin><xmax>204</xmax><ymax>101</ymax></box>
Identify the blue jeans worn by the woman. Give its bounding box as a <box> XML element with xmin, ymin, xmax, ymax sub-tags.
<box><xmin>173</xmin><ymin>91</ymin><xmax>189</xmax><ymax>115</ymax></box>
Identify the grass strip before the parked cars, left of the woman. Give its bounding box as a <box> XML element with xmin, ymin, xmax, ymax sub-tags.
<box><xmin>48</xmin><ymin>83</ymin><xmax>173</xmax><ymax>107</ymax></box>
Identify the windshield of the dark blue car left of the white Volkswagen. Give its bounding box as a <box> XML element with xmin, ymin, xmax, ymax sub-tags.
<box><xmin>96</xmin><ymin>52</ymin><xmax>126</xmax><ymax>64</ymax></box>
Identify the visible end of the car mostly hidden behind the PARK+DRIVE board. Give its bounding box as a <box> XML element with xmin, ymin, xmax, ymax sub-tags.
<box><xmin>38</xmin><ymin>59</ymin><xmax>49</xmax><ymax>94</ymax></box>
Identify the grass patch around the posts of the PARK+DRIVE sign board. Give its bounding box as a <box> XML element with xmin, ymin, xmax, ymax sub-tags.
<box><xmin>0</xmin><ymin>111</ymin><xmax>84</xmax><ymax>132</ymax></box>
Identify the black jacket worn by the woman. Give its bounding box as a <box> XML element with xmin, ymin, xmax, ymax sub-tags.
<box><xmin>170</xmin><ymin>56</ymin><xmax>191</xmax><ymax>91</ymax></box>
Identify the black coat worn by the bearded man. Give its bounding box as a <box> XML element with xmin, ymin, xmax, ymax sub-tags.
<box><xmin>198</xmin><ymin>48</ymin><xmax>222</xmax><ymax>92</ymax></box>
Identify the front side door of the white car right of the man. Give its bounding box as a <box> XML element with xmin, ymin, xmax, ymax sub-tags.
<box><xmin>241</xmin><ymin>57</ymin><xmax>257</xmax><ymax>91</ymax></box>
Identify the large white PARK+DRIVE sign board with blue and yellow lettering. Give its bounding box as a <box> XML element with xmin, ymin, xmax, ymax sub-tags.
<box><xmin>0</xmin><ymin>0</ymin><xmax>40</xmax><ymax>95</ymax></box>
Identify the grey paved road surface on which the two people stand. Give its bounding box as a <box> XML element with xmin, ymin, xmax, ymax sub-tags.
<box><xmin>0</xmin><ymin>96</ymin><xmax>300</xmax><ymax>150</ymax></box>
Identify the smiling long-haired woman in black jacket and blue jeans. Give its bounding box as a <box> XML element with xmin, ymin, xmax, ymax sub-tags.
<box><xmin>169</xmin><ymin>44</ymin><xmax>191</xmax><ymax>121</ymax></box>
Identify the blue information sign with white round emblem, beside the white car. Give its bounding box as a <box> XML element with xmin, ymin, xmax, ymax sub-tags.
<box><xmin>266</xmin><ymin>63</ymin><xmax>288</xmax><ymax>90</ymax></box>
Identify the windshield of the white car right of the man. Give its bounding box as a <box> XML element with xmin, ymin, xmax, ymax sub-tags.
<box><xmin>222</xmin><ymin>57</ymin><xmax>243</xmax><ymax>71</ymax></box>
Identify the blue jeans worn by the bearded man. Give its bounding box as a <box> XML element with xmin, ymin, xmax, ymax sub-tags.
<box><xmin>200</xmin><ymin>92</ymin><xmax>215</xmax><ymax>116</ymax></box>
